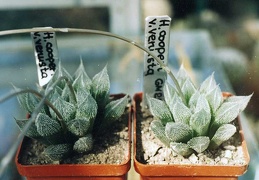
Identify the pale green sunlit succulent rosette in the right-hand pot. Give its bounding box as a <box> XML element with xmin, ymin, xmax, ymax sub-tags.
<box><xmin>147</xmin><ymin>66</ymin><xmax>252</xmax><ymax>156</ymax></box>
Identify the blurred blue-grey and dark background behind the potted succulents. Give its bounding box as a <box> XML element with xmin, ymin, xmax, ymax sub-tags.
<box><xmin>0</xmin><ymin>0</ymin><xmax>259</xmax><ymax>180</ymax></box>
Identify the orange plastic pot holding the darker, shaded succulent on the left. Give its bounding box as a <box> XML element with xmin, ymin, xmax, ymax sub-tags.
<box><xmin>15</xmin><ymin>94</ymin><xmax>131</xmax><ymax>180</ymax></box>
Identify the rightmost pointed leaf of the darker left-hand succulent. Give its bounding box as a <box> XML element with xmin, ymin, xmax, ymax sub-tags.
<box><xmin>104</xmin><ymin>95</ymin><xmax>128</xmax><ymax>123</ymax></box>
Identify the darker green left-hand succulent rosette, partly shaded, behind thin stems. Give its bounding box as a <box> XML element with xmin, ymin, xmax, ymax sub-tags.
<box><xmin>15</xmin><ymin>62</ymin><xmax>128</xmax><ymax>161</ymax></box>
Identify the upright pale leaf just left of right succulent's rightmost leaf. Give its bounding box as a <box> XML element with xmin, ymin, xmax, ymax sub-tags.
<box><xmin>206</xmin><ymin>85</ymin><xmax>223</xmax><ymax>114</ymax></box>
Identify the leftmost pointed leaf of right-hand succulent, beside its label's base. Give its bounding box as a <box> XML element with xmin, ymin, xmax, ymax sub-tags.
<box><xmin>147</xmin><ymin>95</ymin><xmax>173</xmax><ymax>125</ymax></box>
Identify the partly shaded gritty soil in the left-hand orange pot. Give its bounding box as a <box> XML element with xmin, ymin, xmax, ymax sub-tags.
<box><xmin>19</xmin><ymin>109</ymin><xmax>130</xmax><ymax>165</ymax></box>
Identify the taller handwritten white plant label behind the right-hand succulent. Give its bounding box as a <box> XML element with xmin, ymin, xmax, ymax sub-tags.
<box><xmin>143</xmin><ymin>16</ymin><xmax>171</xmax><ymax>107</ymax></box>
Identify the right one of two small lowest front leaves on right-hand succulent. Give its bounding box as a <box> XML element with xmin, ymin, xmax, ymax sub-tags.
<box><xmin>187</xmin><ymin>136</ymin><xmax>210</xmax><ymax>153</ymax></box>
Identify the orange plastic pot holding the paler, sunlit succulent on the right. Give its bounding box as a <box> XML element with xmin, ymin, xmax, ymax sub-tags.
<box><xmin>133</xmin><ymin>93</ymin><xmax>250</xmax><ymax>180</ymax></box>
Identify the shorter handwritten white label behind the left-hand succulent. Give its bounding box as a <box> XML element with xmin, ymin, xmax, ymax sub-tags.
<box><xmin>31</xmin><ymin>28</ymin><xmax>59</xmax><ymax>86</ymax></box>
